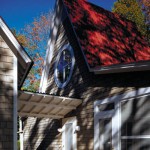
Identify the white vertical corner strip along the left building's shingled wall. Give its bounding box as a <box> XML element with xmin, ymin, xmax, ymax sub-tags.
<box><xmin>13</xmin><ymin>55</ymin><xmax>18</xmax><ymax>150</ymax></box>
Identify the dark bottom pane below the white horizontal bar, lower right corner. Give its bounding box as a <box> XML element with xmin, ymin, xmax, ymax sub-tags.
<box><xmin>121</xmin><ymin>139</ymin><xmax>150</xmax><ymax>150</ymax></box>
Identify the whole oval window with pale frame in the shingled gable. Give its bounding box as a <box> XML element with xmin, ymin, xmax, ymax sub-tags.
<box><xmin>54</xmin><ymin>44</ymin><xmax>75</xmax><ymax>88</ymax></box>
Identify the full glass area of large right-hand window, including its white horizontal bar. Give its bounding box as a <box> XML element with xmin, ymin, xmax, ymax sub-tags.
<box><xmin>121</xmin><ymin>96</ymin><xmax>150</xmax><ymax>150</ymax></box>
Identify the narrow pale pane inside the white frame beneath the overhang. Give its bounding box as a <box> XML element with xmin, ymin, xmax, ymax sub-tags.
<box><xmin>65</xmin><ymin>123</ymin><xmax>73</xmax><ymax>150</ymax></box>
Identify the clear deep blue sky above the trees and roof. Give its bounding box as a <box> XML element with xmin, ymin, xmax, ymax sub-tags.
<box><xmin>0</xmin><ymin>0</ymin><xmax>116</xmax><ymax>31</ymax></box>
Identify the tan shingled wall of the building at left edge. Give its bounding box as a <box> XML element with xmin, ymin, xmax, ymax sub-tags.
<box><xmin>0</xmin><ymin>36</ymin><xmax>13</xmax><ymax>150</ymax></box>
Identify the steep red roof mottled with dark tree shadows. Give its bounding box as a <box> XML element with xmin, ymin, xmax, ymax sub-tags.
<box><xmin>64</xmin><ymin>0</ymin><xmax>150</xmax><ymax>73</ymax></box>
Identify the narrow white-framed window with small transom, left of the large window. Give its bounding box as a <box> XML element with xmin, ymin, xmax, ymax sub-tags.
<box><xmin>94</xmin><ymin>101</ymin><xmax>116</xmax><ymax>150</ymax></box>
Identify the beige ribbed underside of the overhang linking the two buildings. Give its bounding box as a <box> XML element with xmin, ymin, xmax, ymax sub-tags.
<box><xmin>18</xmin><ymin>91</ymin><xmax>82</xmax><ymax>119</ymax></box>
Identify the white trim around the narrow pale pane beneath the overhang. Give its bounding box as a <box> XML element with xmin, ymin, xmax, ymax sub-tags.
<box><xmin>62</xmin><ymin>117</ymin><xmax>77</xmax><ymax>150</ymax></box>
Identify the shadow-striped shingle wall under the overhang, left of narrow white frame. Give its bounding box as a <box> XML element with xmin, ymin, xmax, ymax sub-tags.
<box><xmin>23</xmin><ymin>117</ymin><xmax>61</xmax><ymax>150</ymax></box>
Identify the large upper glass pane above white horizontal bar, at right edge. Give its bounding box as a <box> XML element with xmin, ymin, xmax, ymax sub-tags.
<box><xmin>121</xmin><ymin>97</ymin><xmax>150</xmax><ymax>136</ymax></box>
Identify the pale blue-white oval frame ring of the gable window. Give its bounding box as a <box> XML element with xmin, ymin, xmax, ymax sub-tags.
<box><xmin>54</xmin><ymin>44</ymin><xmax>75</xmax><ymax>88</ymax></box>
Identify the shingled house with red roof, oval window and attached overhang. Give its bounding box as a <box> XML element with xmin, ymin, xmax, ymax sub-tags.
<box><xmin>0</xmin><ymin>0</ymin><xmax>150</xmax><ymax>150</ymax></box>
